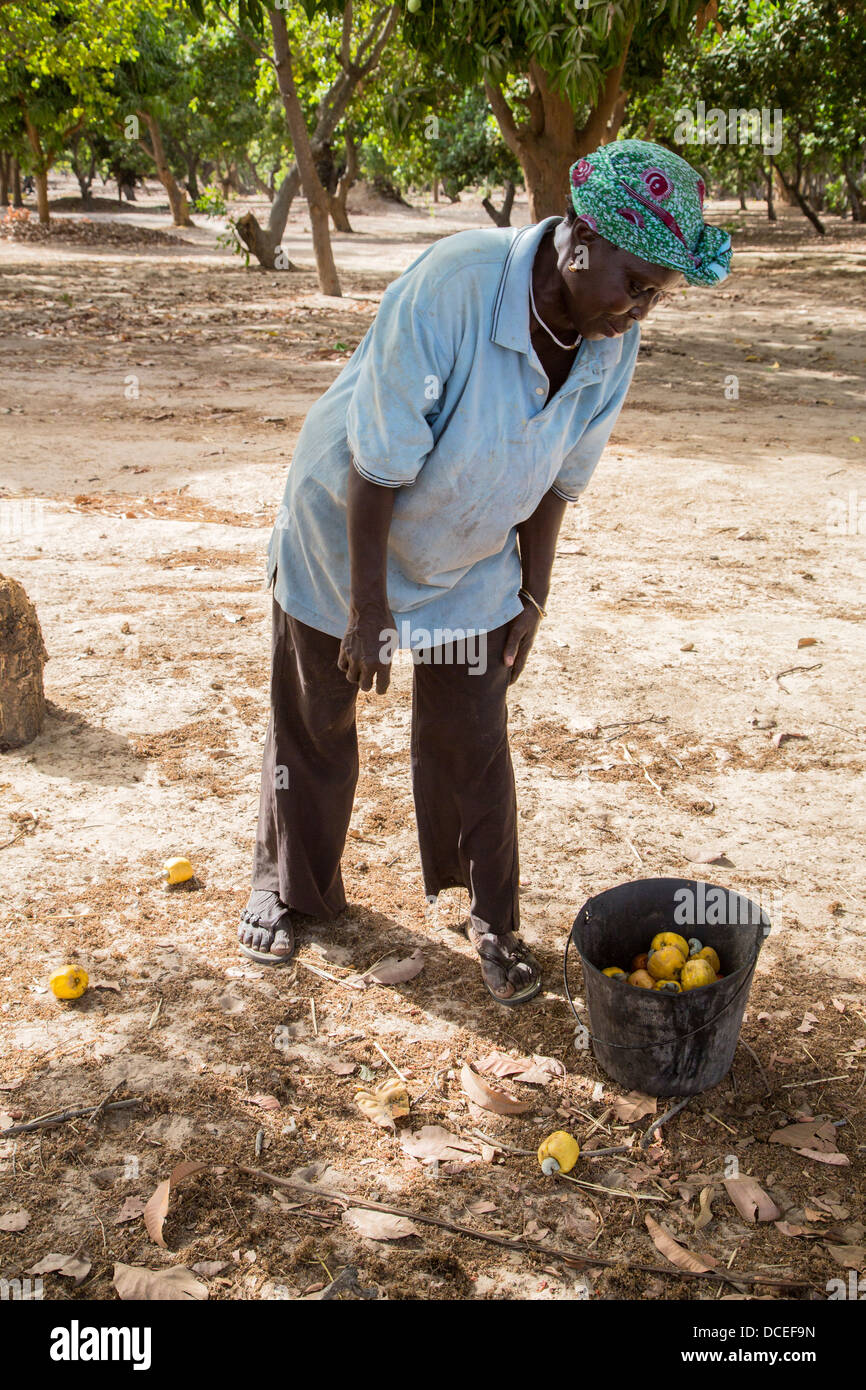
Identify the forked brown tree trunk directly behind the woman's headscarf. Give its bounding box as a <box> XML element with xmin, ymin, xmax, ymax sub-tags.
<box><xmin>484</xmin><ymin>33</ymin><xmax>631</xmax><ymax>222</ymax></box>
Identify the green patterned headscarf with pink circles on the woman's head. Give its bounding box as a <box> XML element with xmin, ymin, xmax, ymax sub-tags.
<box><xmin>569</xmin><ymin>140</ymin><xmax>731</xmax><ymax>285</ymax></box>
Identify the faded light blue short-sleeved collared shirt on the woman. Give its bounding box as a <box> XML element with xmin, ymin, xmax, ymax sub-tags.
<box><xmin>268</xmin><ymin>217</ymin><xmax>639</xmax><ymax>648</ymax></box>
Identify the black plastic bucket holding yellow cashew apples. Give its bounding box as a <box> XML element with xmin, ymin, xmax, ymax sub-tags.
<box><xmin>564</xmin><ymin>878</ymin><xmax>770</xmax><ymax>1095</ymax></box>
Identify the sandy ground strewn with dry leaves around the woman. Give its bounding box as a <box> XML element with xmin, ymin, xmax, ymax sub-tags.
<box><xmin>0</xmin><ymin>176</ymin><xmax>866</xmax><ymax>1300</ymax></box>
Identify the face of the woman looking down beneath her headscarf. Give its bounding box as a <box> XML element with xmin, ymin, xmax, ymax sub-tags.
<box><xmin>555</xmin><ymin>218</ymin><xmax>683</xmax><ymax>339</ymax></box>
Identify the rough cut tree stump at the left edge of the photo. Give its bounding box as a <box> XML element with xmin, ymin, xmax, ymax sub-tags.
<box><xmin>0</xmin><ymin>574</ymin><xmax>49</xmax><ymax>752</ymax></box>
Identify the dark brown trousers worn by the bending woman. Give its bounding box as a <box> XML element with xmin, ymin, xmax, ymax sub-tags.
<box><xmin>253</xmin><ymin>600</ymin><xmax>518</xmax><ymax>934</ymax></box>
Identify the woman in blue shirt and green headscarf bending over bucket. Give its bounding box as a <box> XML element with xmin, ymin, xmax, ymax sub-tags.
<box><xmin>238</xmin><ymin>140</ymin><xmax>730</xmax><ymax>1005</ymax></box>
